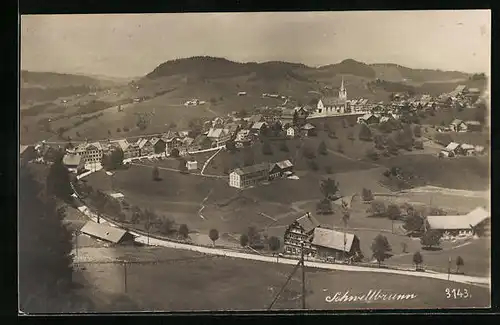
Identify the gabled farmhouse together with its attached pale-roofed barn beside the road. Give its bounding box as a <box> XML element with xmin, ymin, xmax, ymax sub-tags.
<box><xmin>283</xmin><ymin>212</ymin><xmax>362</xmax><ymax>259</ymax></box>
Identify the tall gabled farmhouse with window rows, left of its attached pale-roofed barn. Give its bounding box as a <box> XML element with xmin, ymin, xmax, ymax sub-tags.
<box><xmin>283</xmin><ymin>212</ymin><xmax>320</xmax><ymax>256</ymax></box>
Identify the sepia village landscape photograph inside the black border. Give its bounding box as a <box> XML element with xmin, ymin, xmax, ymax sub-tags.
<box><xmin>18</xmin><ymin>10</ymin><xmax>491</xmax><ymax>315</ymax></box>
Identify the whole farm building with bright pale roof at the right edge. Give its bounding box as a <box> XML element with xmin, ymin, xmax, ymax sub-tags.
<box><xmin>426</xmin><ymin>207</ymin><xmax>491</xmax><ymax>236</ymax></box>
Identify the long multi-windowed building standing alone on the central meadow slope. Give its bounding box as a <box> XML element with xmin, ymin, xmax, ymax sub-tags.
<box><xmin>229</xmin><ymin>160</ymin><xmax>294</xmax><ymax>189</ymax></box>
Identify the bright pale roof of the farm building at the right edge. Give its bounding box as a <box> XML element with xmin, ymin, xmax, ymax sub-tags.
<box><xmin>427</xmin><ymin>207</ymin><xmax>490</xmax><ymax>230</ymax></box>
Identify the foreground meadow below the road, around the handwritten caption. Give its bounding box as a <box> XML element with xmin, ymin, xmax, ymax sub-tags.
<box><xmin>76</xmin><ymin>244</ymin><xmax>489</xmax><ymax>311</ymax></box>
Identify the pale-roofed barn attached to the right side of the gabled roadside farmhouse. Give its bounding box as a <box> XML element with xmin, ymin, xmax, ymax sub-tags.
<box><xmin>311</xmin><ymin>227</ymin><xmax>361</xmax><ymax>258</ymax></box>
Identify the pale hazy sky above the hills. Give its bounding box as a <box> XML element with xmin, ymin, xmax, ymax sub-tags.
<box><xmin>21</xmin><ymin>10</ymin><xmax>491</xmax><ymax>77</ymax></box>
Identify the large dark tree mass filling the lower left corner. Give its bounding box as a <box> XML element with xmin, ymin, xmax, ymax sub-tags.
<box><xmin>18</xmin><ymin>167</ymin><xmax>74</xmax><ymax>313</ymax></box>
